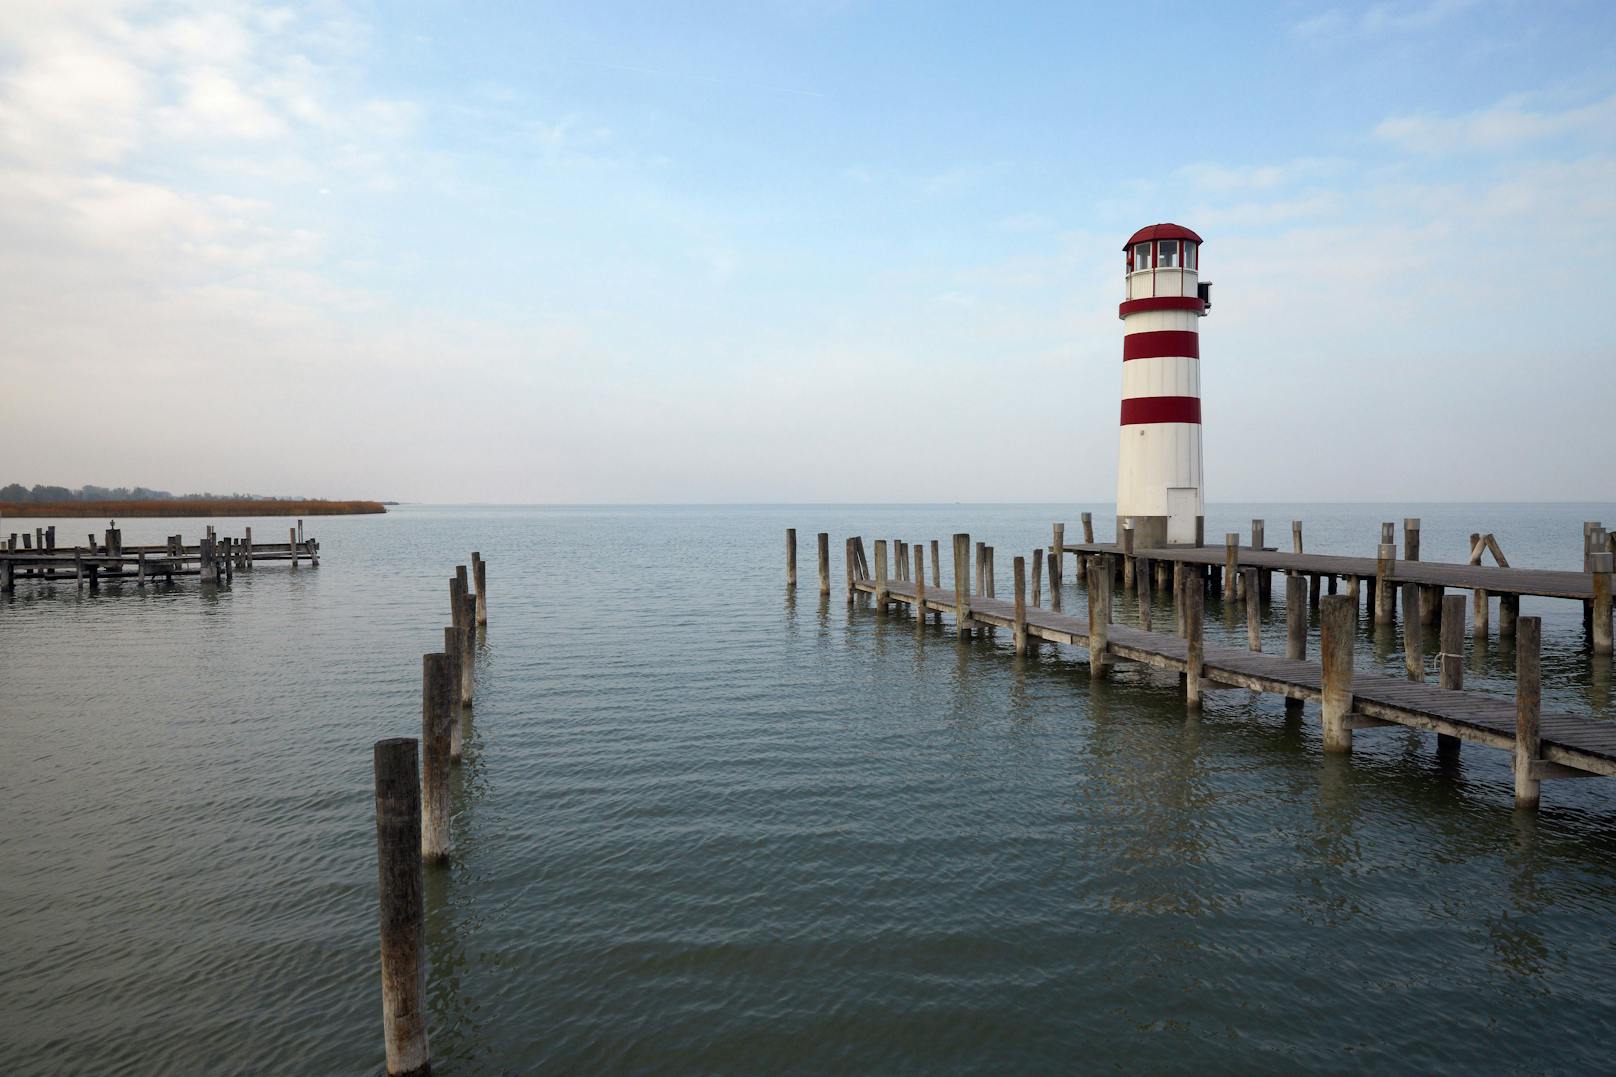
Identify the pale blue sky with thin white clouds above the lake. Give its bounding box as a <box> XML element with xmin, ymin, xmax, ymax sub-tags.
<box><xmin>0</xmin><ymin>0</ymin><xmax>1616</xmax><ymax>503</ymax></box>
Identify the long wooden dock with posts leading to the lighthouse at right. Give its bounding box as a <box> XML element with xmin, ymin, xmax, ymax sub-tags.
<box><xmin>787</xmin><ymin>527</ymin><xmax>1616</xmax><ymax>807</ymax></box>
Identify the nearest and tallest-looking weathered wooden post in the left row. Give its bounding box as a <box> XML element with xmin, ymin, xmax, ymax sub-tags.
<box><xmin>373</xmin><ymin>737</ymin><xmax>431</xmax><ymax>1077</ymax></box>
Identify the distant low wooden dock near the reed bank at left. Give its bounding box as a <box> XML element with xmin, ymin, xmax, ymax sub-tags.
<box><xmin>0</xmin><ymin>521</ymin><xmax>320</xmax><ymax>595</ymax></box>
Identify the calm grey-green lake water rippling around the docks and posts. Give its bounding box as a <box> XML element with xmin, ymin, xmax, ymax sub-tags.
<box><xmin>0</xmin><ymin>505</ymin><xmax>1616</xmax><ymax>1074</ymax></box>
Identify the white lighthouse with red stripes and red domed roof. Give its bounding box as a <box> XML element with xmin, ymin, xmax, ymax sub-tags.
<box><xmin>1117</xmin><ymin>225</ymin><xmax>1212</xmax><ymax>547</ymax></box>
